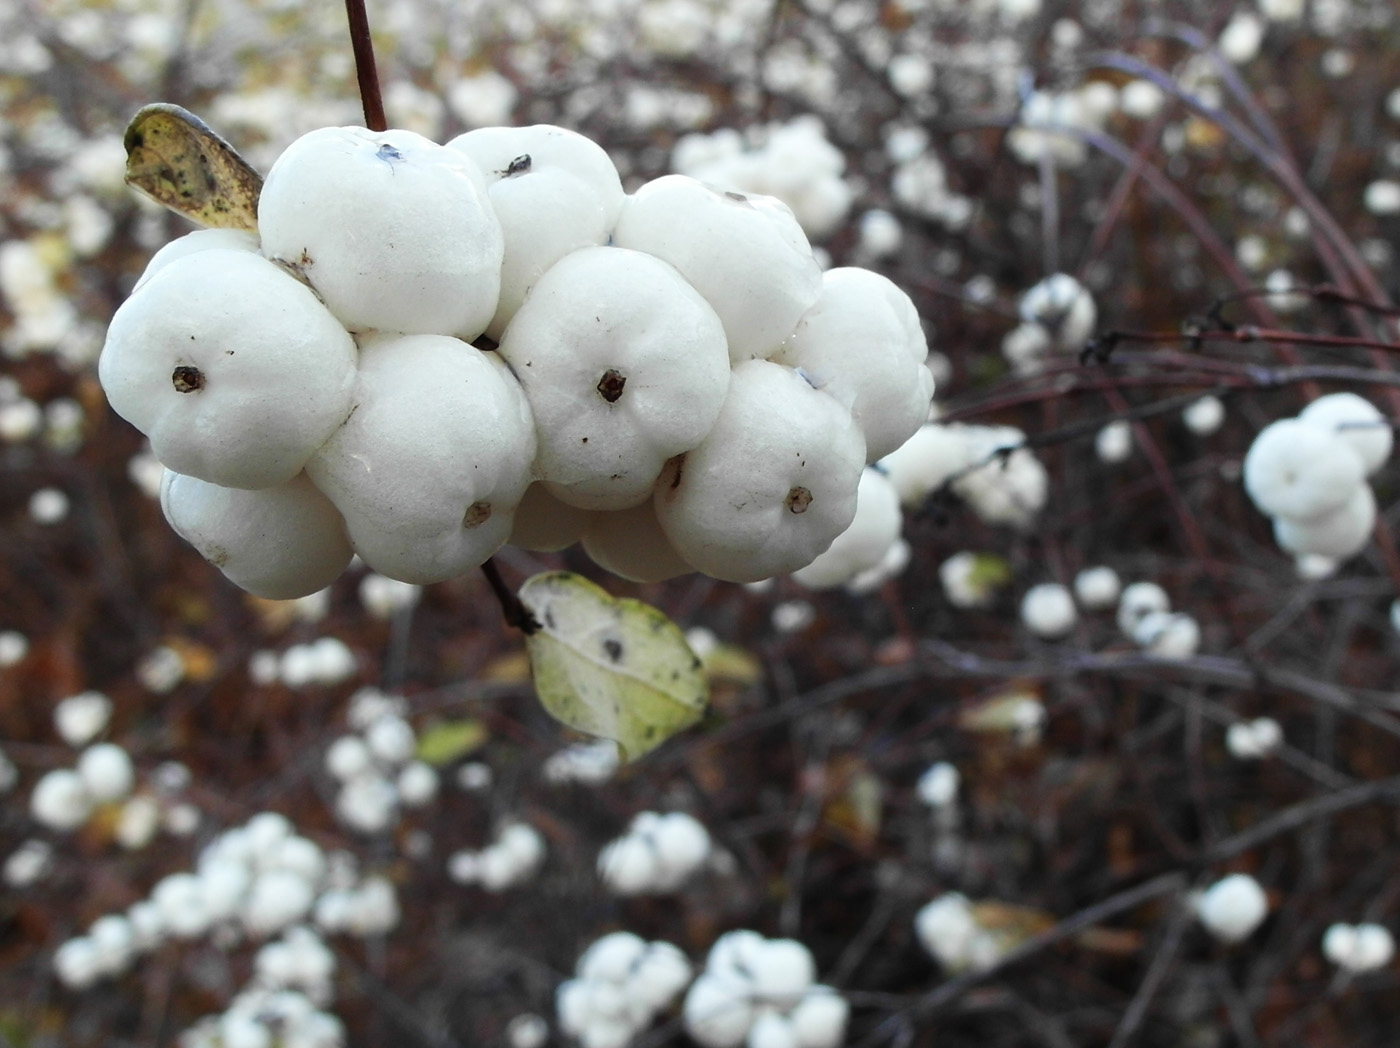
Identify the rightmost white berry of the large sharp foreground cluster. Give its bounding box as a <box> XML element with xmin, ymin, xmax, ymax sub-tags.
<box><xmin>770</xmin><ymin>267</ymin><xmax>934</xmax><ymax>460</ymax></box>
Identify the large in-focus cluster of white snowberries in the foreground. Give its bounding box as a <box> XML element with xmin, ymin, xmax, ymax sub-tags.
<box><xmin>98</xmin><ymin>125</ymin><xmax>934</xmax><ymax>599</ymax></box>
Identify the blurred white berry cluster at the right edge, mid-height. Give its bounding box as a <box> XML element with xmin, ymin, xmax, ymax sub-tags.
<box><xmin>1245</xmin><ymin>393</ymin><xmax>1393</xmax><ymax>575</ymax></box>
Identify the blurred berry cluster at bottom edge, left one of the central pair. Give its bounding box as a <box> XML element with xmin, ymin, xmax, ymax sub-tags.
<box><xmin>554</xmin><ymin>932</ymin><xmax>690</xmax><ymax>1048</ymax></box>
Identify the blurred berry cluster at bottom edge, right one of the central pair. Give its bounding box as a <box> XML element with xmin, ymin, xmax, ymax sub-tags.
<box><xmin>682</xmin><ymin>930</ymin><xmax>850</xmax><ymax>1048</ymax></box>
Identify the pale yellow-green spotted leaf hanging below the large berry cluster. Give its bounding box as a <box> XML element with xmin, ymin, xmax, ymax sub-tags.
<box><xmin>519</xmin><ymin>571</ymin><xmax>708</xmax><ymax>760</ymax></box>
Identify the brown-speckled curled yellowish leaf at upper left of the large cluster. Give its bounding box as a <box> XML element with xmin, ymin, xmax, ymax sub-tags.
<box><xmin>123</xmin><ymin>102</ymin><xmax>262</xmax><ymax>232</ymax></box>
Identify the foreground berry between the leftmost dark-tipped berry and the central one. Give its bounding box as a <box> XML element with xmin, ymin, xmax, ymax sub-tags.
<box><xmin>307</xmin><ymin>334</ymin><xmax>535</xmax><ymax>583</ymax></box>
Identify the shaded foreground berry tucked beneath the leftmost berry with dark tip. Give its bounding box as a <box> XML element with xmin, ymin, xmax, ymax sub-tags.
<box><xmin>161</xmin><ymin>470</ymin><xmax>353</xmax><ymax>600</ymax></box>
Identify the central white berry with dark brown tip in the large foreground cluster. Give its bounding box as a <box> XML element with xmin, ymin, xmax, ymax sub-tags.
<box><xmin>500</xmin><ymin>248</ymin><xmax>729</xmax><ymax>509</ymax></box>
